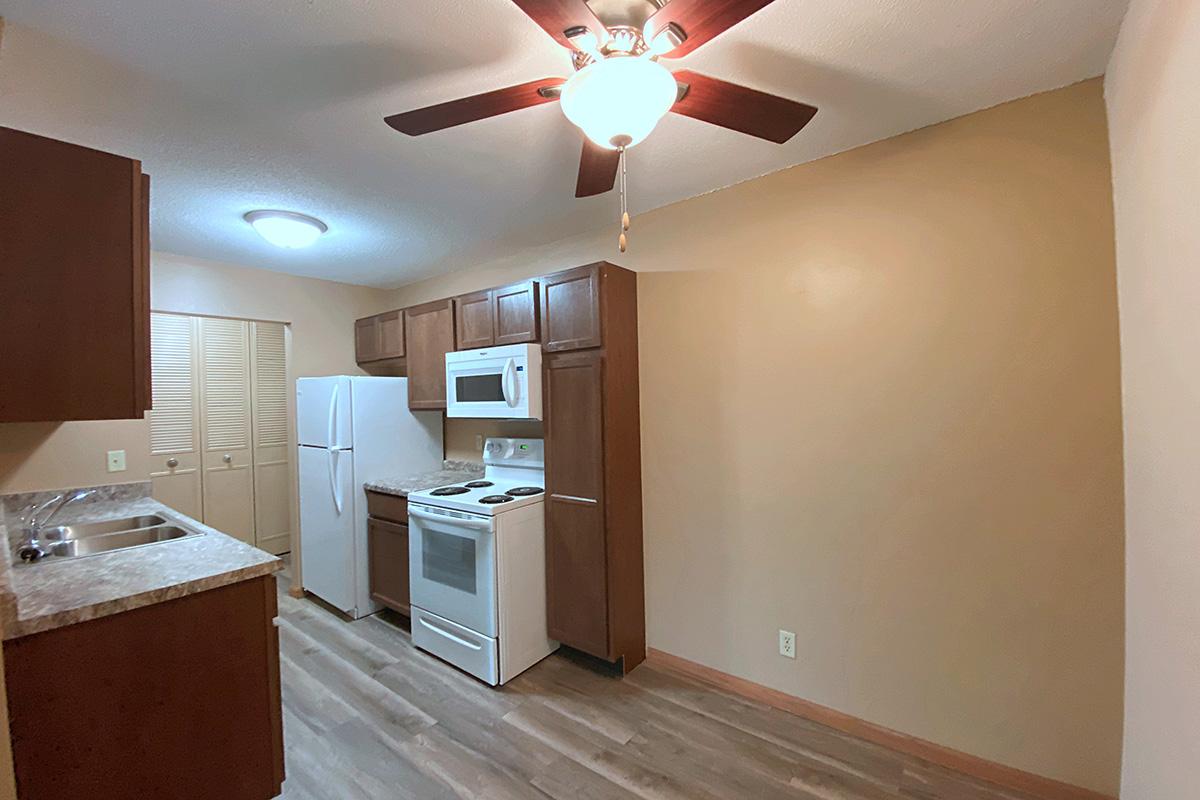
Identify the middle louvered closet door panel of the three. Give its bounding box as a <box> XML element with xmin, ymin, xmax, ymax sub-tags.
<box><xmin>199</xmin><ymin>318</ymin><xmax>254</xmax><ymax>545</ymax></box>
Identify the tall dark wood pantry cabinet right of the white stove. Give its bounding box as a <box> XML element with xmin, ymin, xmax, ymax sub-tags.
<box><xmin>541</xmin><ymin>263</ymin><xmax>646</xmax><ymax>673</ymax></box>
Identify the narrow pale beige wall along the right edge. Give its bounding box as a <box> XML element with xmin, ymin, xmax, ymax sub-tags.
<box><xmin>1105</xmin><ymin>0</ymin><xmax>1200</xmax><ymax>800</ymax></box>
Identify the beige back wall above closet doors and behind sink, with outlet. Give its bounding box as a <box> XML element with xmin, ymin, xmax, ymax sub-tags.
<box><xmin>0</xmin><ymin>253</ymin><xmax>390</xmax><ymax>494</ymax></box>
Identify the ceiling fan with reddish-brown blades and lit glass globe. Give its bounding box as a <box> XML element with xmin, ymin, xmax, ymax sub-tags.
<box><xmin>385</xmin><ymin>0</ymin><xmax>817</xmax><ymax>249</ymax></box>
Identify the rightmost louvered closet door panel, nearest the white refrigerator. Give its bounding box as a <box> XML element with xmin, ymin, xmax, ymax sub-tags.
<box><xmin>250</xmin><ymin>323</ymin><xmax>292</xmax><ymax>554</ymax></box>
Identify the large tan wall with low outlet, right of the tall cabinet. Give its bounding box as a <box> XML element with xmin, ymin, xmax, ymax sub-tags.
<box><xmin>396</xmin><ymin>80</ymin><xmax>1123</xmax><ymax>794</ymax></box>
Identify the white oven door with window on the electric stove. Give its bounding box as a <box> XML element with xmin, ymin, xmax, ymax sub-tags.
<box><xmin>408</xmin><ymin>505</ymin><xmax>497</xmax><ymax>638</ymax></box>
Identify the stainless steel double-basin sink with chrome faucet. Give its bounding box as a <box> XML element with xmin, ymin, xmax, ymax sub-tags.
<box><xmin>13</xmin><ymin>515</ymin><xmax>203</xmax><ymax>564</ymax></box>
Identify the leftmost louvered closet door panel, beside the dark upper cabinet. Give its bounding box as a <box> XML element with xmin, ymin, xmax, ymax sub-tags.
<box><xmin>150</xmin><ymin>314</ymin><xmax>204</xmax><ymax>519</ymax></box>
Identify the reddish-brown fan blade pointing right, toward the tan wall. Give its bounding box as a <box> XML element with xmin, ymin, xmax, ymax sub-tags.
<box><xmin>667</xmin><ymin>70</ymin><xmax>817</xmax><ymax>144</ymax></box>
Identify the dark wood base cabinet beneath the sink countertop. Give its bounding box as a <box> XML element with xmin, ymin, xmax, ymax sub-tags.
<box><xmin>4</xmin><ymin>576</ymin><xmax>283</xmax><ymax>800</ymax></box>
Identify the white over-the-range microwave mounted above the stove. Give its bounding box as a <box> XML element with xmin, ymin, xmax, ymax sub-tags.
<box><xmin>446</xmin><ymin>353</ymin><xmax>532</xmax><ymax>420</ymax></box>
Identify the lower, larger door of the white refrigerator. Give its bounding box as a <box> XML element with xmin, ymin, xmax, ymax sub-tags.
<box><xmin>299</xmin><ymin>446</ymin><xmax>358</xmax><ymax>615</ymax></box>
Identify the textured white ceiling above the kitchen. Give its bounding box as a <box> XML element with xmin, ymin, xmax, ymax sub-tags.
<box><xmin>0</xmin><ymin>0</ymin><xmax>1127</xmax><ymax>285</ymax></box>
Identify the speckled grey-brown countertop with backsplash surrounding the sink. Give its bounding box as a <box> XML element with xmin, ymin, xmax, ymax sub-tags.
<box><xmin>0</xmin><ymin>483</ymin><xmax>282</xmax><ymax>639</ymax></box>
